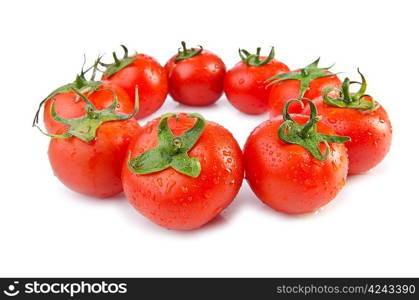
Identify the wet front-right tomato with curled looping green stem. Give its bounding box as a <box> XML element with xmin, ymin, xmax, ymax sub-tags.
<box><xmin>244</xmin><ymin>100</ymin><xmax>348</xmax><ymax>214</ymax></box>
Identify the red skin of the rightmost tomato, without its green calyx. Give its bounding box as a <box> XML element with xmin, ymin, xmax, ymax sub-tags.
<box><xmin>304</xmin><ymin>97</ymin><xmax>392</xmax><ymax>174</ymax></box>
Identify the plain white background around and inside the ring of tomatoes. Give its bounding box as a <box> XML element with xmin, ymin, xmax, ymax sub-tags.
<box><xmin>0</xmin><ymin>0</ymin><xmax>419</xmax><ymax>277</ymax></box>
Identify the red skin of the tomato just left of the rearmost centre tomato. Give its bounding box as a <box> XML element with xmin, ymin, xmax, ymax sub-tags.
<box><xmin>103</xmin><ymin>54</ymin><xmax>169</xmax><ymax>119</ymax></box>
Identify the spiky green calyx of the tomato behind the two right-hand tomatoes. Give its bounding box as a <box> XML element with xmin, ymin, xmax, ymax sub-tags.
<box><xmin>266</xmin><ymin>57</ymin><xmax>336</xmax><ymax>98</ymax></box>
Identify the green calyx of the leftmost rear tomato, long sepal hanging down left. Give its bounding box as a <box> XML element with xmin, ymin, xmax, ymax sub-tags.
<box><xmin>32</xmin><ymin>56</ymin><xmax>103</xmax><ymax>127</ymax></box>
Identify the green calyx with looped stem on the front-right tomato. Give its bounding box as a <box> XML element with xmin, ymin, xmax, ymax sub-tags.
<box><xmin>278</xmin><ymin>98</ymin><xmax>351</xmax><ymax>161</ymax></box>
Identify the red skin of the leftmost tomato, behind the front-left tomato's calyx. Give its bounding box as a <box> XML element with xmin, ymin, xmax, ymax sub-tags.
<box><xmin>44</xmin><ymin>80</ymin><xmax>134</xmax><ymax>134</ymax></box>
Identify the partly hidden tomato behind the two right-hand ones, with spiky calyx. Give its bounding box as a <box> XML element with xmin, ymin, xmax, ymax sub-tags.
<box><xmin>268</xmin><ymin>59</ymin><xmax>342</xmax><ymax>118</ymax></box>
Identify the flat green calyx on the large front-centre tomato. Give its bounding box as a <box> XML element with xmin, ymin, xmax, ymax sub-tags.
<box><xmin>128</xmin><ymin>113</ymin><xmax>205</xmax><ymax>178</ymax></box>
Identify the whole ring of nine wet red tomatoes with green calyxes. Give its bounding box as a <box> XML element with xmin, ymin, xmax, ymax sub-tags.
<box><xmin>33</xmin><ymin>42</ymin><xmax>392</xmax><ymax>230</ymax></box>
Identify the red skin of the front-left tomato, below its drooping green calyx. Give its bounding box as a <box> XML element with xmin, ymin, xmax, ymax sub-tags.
<box><xmin>48</xmin><ymin>119</ymin><xmax>140</xmax><ymax>198</ymax></box>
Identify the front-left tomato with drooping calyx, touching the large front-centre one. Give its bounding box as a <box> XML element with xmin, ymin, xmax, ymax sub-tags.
<box><xmin>48</xmin><ymin>92</ymin><xmax>140</xmax><ymax>198</ymax></box>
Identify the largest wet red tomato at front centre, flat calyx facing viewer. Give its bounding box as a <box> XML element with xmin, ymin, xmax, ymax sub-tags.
<box><xmin>122</xmin><ymin>114</ymin><xmax>244</xmax><ymax>230</ymax></box>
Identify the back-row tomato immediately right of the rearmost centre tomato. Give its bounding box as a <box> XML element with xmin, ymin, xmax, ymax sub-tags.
<box><xmin>224</xmin><ymin>47</ymin><xmax>289</xmax><ymax>114</ymax></box>
